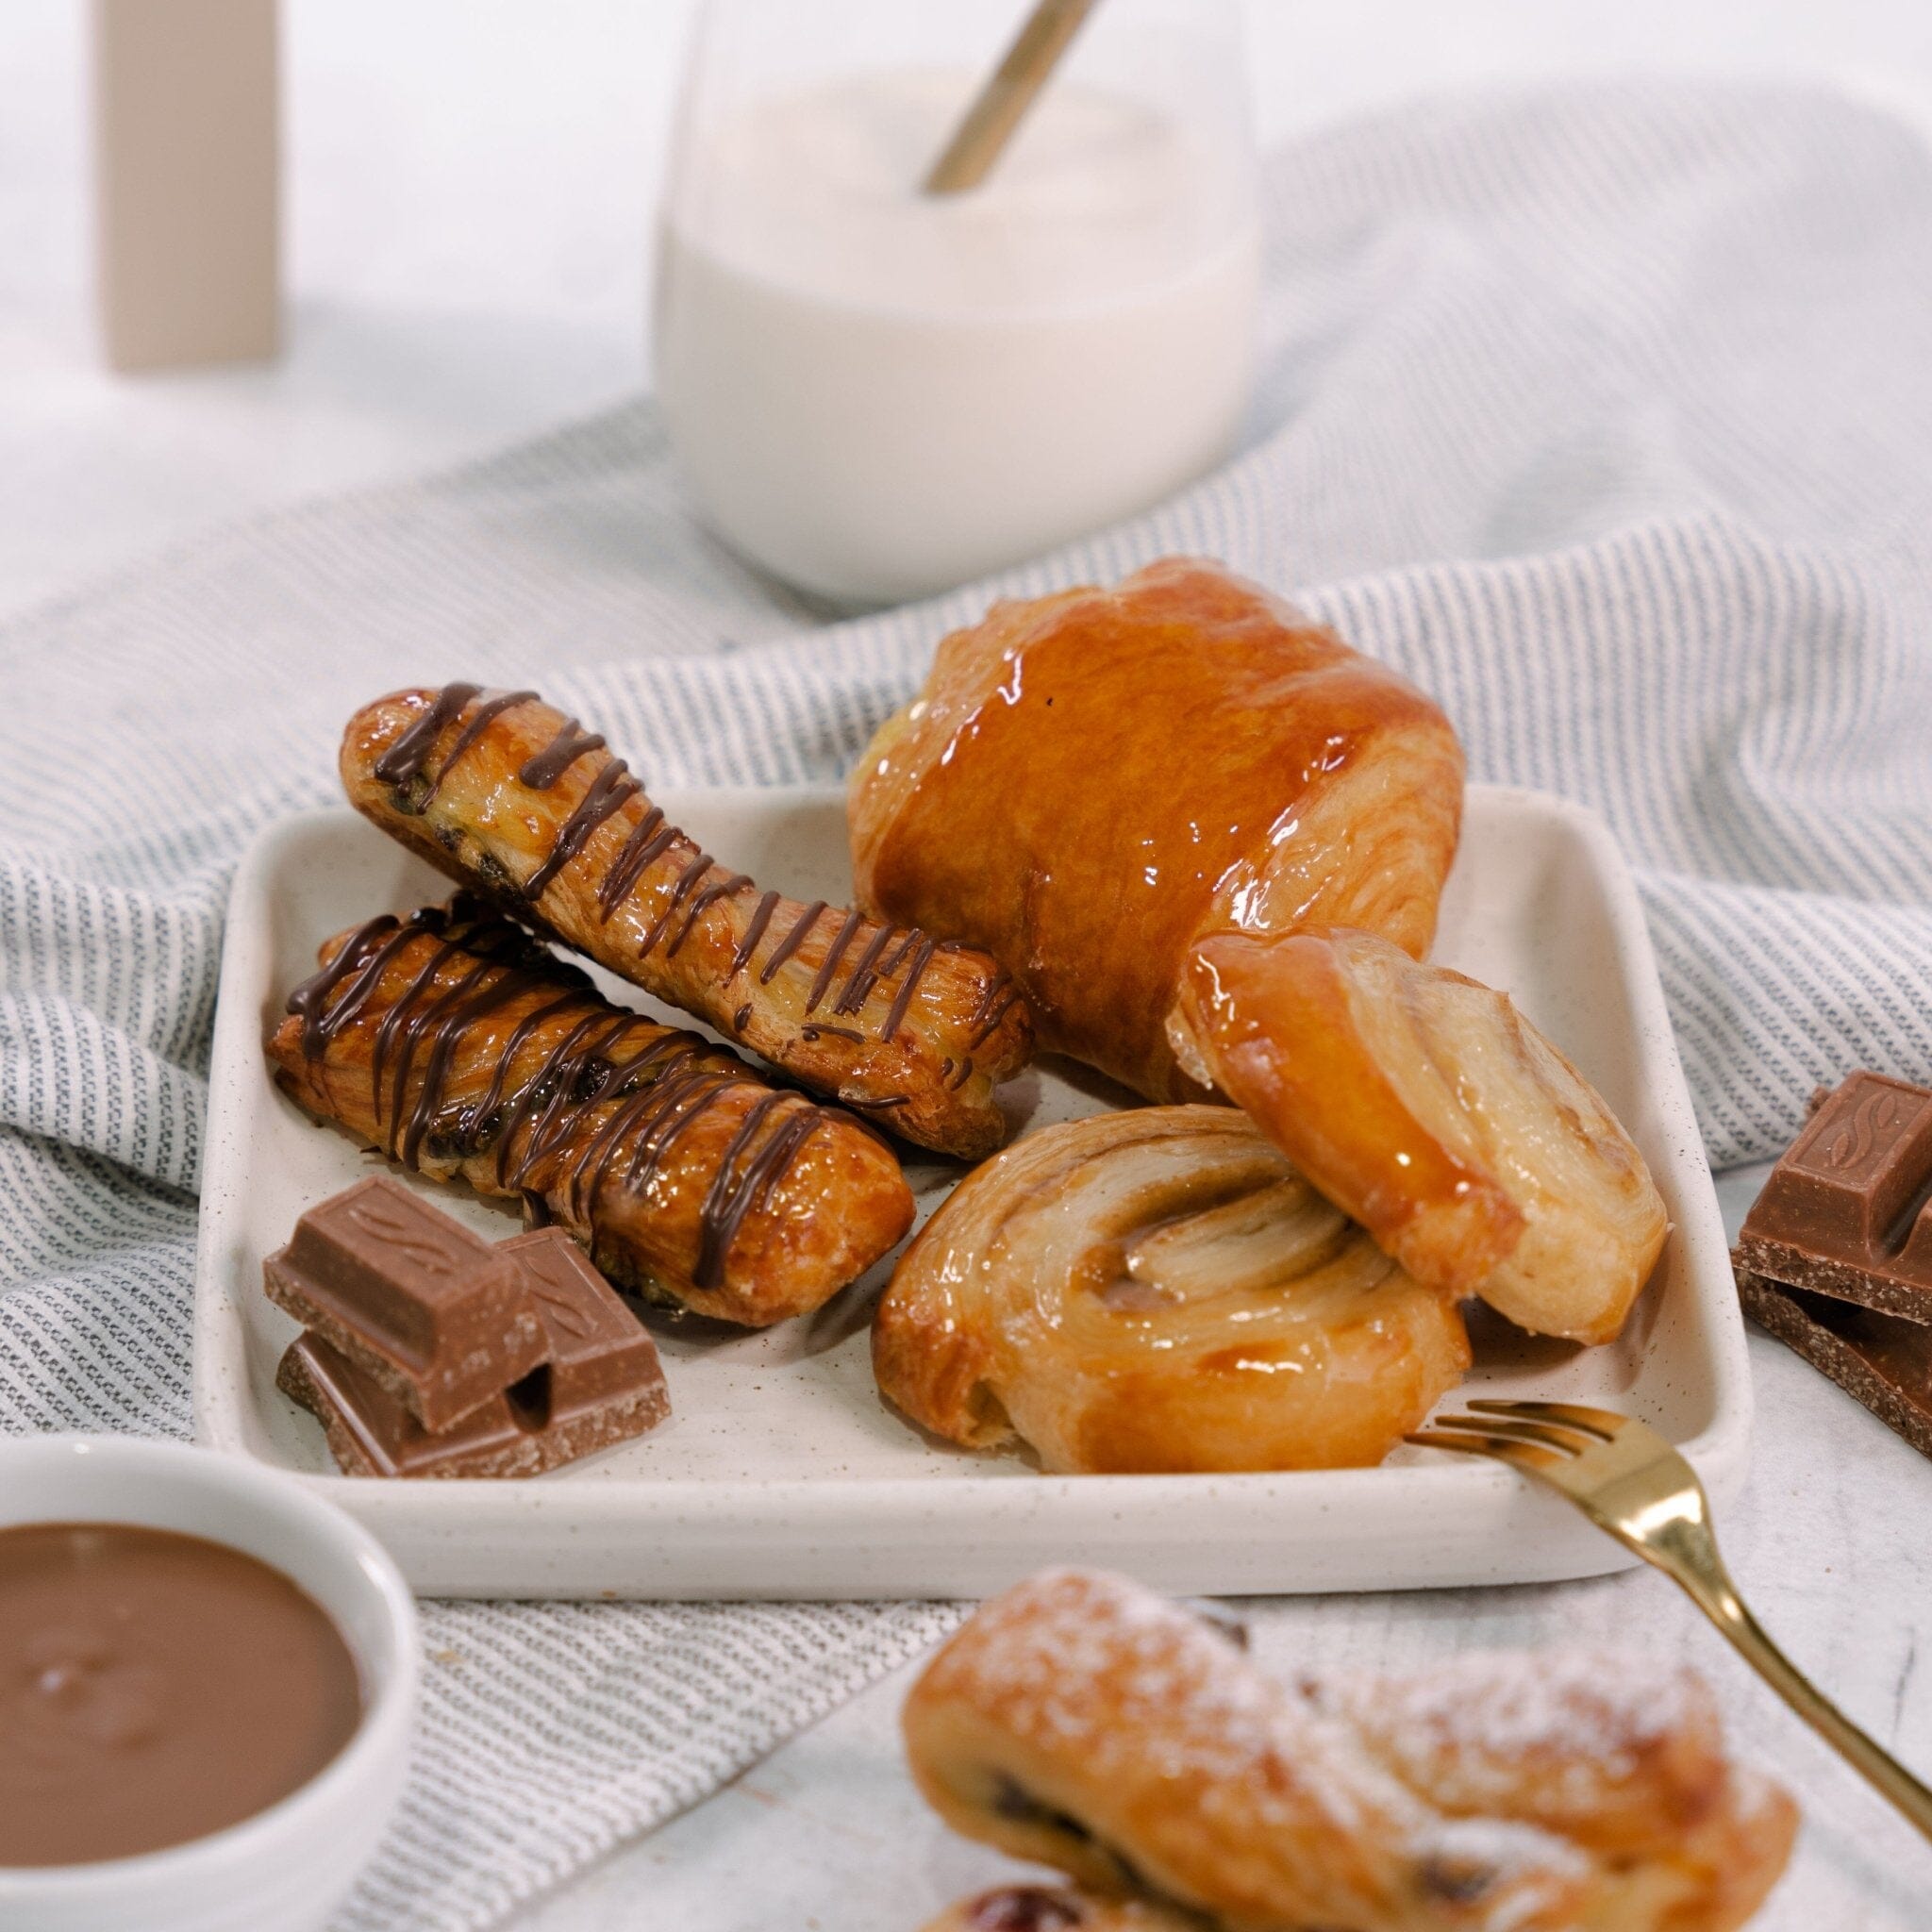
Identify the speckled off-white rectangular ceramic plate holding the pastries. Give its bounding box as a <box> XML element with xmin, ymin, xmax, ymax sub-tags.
<box><xmin>195</xmin><ymin>787</ymin><xmax>1750</xmax><ymax>1598</ymax></box>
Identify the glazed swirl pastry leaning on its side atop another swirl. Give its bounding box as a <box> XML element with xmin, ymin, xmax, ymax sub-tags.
<box><xmin>1174</xmin><ymin>931</ymin><xmax>1669</xmax><ymax>1342</ymax></box>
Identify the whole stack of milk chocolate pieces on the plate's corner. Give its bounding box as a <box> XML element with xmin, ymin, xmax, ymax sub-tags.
<box><xmin>263</xmin><ymin>1174</ymin><xmax>671</xmax><ymax>1476</ymax></box>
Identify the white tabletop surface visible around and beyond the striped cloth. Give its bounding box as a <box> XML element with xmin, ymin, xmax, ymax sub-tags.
<box><xmin>11</xmin><ymin>0</ymin><xmax>1932</xmax><ymax>1932</ymax></box>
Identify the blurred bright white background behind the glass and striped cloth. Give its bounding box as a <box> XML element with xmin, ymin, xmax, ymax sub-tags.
<box><xmin>0</xmin><ymin>0</ymin><xmax>1932</xmax><ymax>608</ymax></box>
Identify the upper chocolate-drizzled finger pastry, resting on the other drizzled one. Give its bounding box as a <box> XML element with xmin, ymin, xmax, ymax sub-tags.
<box><xmin>341</xmin><ymin>684</ymin><xmax>1034</xmax><ymax>1159</ymax></box>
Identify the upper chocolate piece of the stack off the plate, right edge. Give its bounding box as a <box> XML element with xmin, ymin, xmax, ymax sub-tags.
<box><xmin>1735</xmin><ymin>1073</ymin><xmax>1932</xmax><ymax>1322</ymax></box>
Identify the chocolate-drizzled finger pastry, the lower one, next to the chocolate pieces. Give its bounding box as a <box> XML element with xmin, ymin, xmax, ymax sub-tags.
<box><xmin>269</xmin><ymin>894</ymin><xmax>912</xmax><ymax>1327</ymax></box>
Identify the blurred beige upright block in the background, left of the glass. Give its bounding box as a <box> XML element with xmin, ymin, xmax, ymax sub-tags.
<box><xmin>92</xmin><ymin>0</ymin><xmax>280</xmax><ymax>369</ymax></box>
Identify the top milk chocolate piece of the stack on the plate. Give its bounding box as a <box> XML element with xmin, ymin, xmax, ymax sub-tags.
<box><xmin>263</xmin><ymin>1174</ymin><xmax>547</xmax><ymax>1430</ymax></box>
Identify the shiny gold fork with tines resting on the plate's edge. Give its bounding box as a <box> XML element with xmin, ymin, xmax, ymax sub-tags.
<box><xmin>1408</xmin><ymin>1401</ymin><xmax>1932</xmax><ymax>1838</ymax></box>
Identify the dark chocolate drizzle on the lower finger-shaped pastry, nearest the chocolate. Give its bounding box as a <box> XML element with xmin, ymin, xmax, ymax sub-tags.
<box><xmin>288</xmin><ymin>894</ymin><xmax>835</xmax><ymax>1289</ymax></box>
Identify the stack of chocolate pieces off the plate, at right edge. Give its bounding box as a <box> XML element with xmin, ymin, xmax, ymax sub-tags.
<box><xmin>1731</xmin><ymin>1073</ymin><xmax>1932</xmax><ymax>1457</ymax></box>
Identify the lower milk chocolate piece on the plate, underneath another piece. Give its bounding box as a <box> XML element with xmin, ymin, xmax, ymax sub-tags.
<box><xmin>276</xmin><ymin>1229</ymin><xmax>671</xmax><ymax>1476</ymax></box>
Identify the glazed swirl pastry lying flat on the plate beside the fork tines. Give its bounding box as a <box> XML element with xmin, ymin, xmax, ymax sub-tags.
<box><xmin>872</xmin><ymin>1108</ymin><xmax>1468</xmax><ymax>1473</ymax></box>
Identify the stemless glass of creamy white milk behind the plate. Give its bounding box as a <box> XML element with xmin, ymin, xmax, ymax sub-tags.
<box><xmin>653</xmin><ymin>0</ymin><xmax>1259</xmax><ymax>605</ymax></box>
